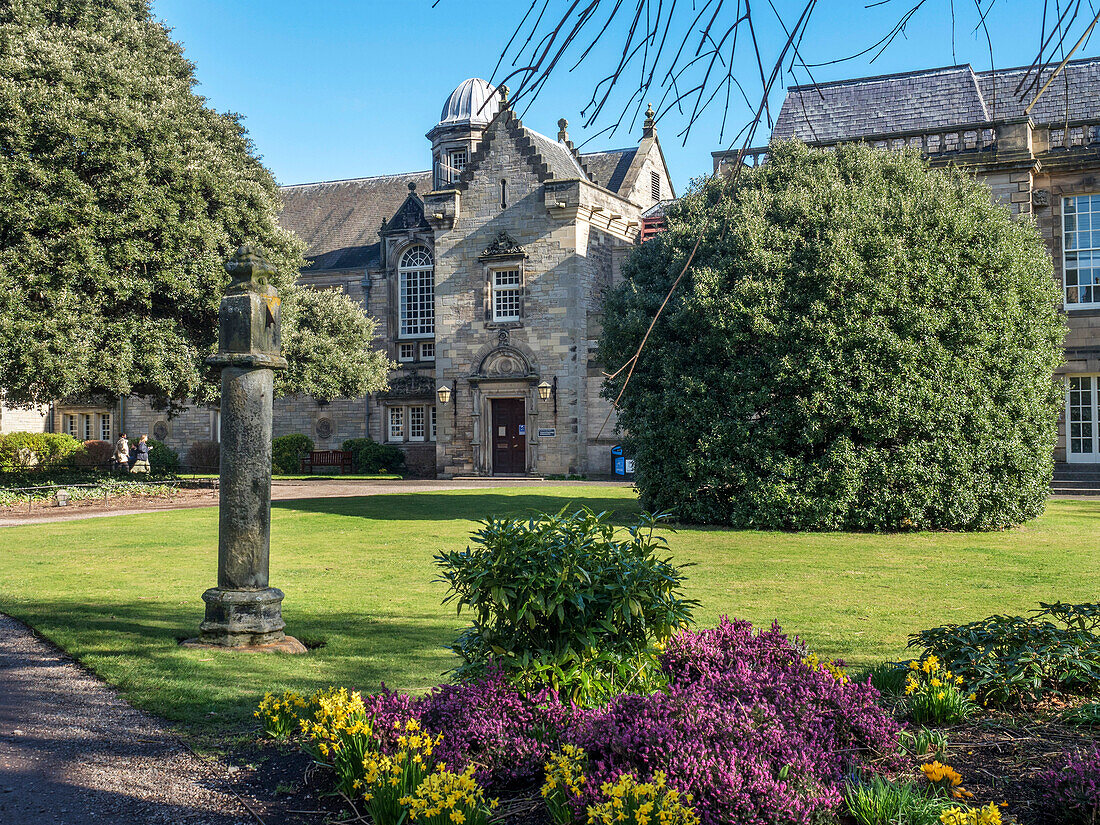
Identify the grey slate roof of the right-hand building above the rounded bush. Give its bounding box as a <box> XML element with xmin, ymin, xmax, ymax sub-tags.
<box><xmin>772</xmin><ymin>57</ymin><xmax>1100</xmax><ymax>143</ymax></box>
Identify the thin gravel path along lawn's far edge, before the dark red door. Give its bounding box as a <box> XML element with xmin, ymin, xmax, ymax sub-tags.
<box><xmin>0</xmin><ymin>479</ymin><xmax>633</xmax><ymax>527</ymax></box>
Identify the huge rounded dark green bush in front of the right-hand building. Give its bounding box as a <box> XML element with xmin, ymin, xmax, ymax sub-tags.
<box><xmin>600</xmin><ymin>143</ymin><xmax>1064</xmax><ymax>530</ymax></box>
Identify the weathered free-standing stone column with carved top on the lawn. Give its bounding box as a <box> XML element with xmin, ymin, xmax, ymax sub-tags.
<box><xmin>187</xmin><ymin>246</ymin><xmax>306</xmax><ymax>653</ymax></box>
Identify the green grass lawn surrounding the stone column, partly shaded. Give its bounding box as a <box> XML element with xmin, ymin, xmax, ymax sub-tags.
<box><xmin>0</xmin><ymin>486</ymin><xmax>1100</xmax><ymax>732</ymax></box>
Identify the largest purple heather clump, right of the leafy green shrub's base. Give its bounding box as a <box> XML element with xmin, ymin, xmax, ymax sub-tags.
<box><xmin>558</xmin><ymin>618</ymin><xmax>898</xmax><ymax>825</ymax></box>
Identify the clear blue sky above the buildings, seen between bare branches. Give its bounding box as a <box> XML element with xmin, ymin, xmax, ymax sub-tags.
<box><xmin>153</xmin><ymin>0</ymin><xmax>1098</xmax><ymax>191</ymax></box>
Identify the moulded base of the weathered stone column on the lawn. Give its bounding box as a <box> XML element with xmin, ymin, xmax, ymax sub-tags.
<box><xmin>185</xmin><ymin>587</ymin><xmax>306</xmax><ymax>652</ymax></box>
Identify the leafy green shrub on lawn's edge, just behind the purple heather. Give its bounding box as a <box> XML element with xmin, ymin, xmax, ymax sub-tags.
<box><xmin>436</xmin><ymin>508</ymin><xmax>696</xmax><ymax>702</ymax></box>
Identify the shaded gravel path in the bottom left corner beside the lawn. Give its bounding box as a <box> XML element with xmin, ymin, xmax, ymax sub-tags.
<box><xmin>0</xmin><ymin>614</ymin><xmax>256</xmax><ymax>825</ymax></box>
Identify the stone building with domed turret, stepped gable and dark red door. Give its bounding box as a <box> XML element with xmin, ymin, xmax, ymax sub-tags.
<box><xmin>15</xmin><ymin>79</ymin><xmax>675</xmax><ymax>476</ymax></box>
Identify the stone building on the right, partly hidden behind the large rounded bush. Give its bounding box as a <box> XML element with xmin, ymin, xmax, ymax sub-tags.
<box><xmin>714</xmin><ymin>58</ymin><xmax>1100</xmax><ymax>484</ymax></box>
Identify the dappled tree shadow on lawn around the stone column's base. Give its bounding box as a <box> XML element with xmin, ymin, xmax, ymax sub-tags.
<box><xmin>0</xmin><ymin>594</ymin><xmax>462</xmax><ymax>733</ymax></box>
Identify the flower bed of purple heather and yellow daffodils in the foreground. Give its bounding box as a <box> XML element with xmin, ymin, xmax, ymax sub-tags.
<box><xmin>261</xmin><ymin>619</ymin><xmax>899</xmax><ymax>825</ymax></box>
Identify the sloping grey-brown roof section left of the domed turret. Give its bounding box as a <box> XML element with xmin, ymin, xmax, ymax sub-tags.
<box><xmin>279</xmin><ymin>171</ymin><xmax>431</xmax><ymax>273</ymax></box>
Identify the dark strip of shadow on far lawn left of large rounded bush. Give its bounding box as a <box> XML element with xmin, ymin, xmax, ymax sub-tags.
<box><xmin>272</xmin><ymin>491</ymin><xmax>639</xmax><ymax>525</ymax></box>
